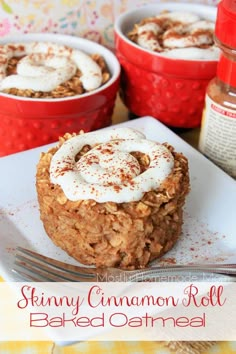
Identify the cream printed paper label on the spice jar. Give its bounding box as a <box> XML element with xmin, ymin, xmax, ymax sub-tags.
<box><xmin>199</xmin><ymin>95</ymin><xmax>236</xmax><ymax>178</ymax></box>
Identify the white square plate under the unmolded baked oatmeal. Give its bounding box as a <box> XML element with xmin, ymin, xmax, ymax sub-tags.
<box><xmin>0</xmin><ymin>117</ymin><xmax>236</xmax><ymax>281</ymax></box>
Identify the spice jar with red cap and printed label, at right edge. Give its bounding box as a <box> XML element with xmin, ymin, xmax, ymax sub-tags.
<box><xmin>199</xmin><ymin>0</ymin><xmax>236</xmax><ymax>178</ymax></box>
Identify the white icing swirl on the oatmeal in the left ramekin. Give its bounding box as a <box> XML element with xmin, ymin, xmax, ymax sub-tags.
<box><xmin>0</xmin><ymin>42</ymin><xmax>102</xmax><ymax>92</ymax></box>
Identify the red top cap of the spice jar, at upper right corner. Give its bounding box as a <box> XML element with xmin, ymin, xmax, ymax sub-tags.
<box><xmin>215</xmin><ymin>0</ymin><xmax>236</xmax><ymax>49</ymax></box>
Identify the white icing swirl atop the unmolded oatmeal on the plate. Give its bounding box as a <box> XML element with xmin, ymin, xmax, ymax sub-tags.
<box><xmin>50</xmin><ymin>128</ymin><xmax>174</xmax><ymax>203</ymax></box>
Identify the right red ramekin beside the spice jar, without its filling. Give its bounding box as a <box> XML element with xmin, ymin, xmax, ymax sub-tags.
<box><xmin>115</xmin><ymin>3</ymin><xmax>217</xmax><ymax>128</ymax></box>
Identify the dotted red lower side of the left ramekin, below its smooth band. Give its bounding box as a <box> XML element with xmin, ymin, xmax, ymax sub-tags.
<box><xmin>0</xmin><ymin>92</ymin><xmax>118</xmax><ymax>156</ymax></box>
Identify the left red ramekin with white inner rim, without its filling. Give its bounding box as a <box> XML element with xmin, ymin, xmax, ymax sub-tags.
<box><xmin>0</xmin><ymin>34</ymin><xmax>120</xmax><ymax>156</ymax></box>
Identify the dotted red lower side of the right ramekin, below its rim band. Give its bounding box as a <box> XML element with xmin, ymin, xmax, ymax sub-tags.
<box><xmin>118</xmin><ymin>53</ymin><xmax>209</xmax><ymax>128</ymax></box>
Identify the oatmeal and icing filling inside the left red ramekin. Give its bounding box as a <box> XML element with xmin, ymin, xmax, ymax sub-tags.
<box><xmin>0</xmin><ymin>42</ymin><xmax>110</xmax><ymax>98</ymax></box>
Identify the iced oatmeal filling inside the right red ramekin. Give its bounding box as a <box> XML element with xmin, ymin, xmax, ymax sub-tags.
<box><xmin>128</xmin><ymin>11</ymin><xmax>219</xmax><ymax>60</ymax></box>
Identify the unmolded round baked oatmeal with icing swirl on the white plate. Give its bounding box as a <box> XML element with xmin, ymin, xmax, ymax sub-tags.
<box><xmin>36</xmin><ymin>128</ymin><xmax>189</xmax><ymax>268</ymax></box>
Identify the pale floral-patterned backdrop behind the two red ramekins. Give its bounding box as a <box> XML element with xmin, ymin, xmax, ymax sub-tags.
<box><xmin>0</xmin><ymin>0</ymin><xmax>218</xmax><ymax>47</ymax></box>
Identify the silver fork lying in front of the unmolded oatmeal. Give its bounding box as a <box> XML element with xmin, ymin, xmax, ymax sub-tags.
<box><xmin>12</xmin><ymin>247</ymin><xmax>236</xmax><ymax>282</ymax></box>
